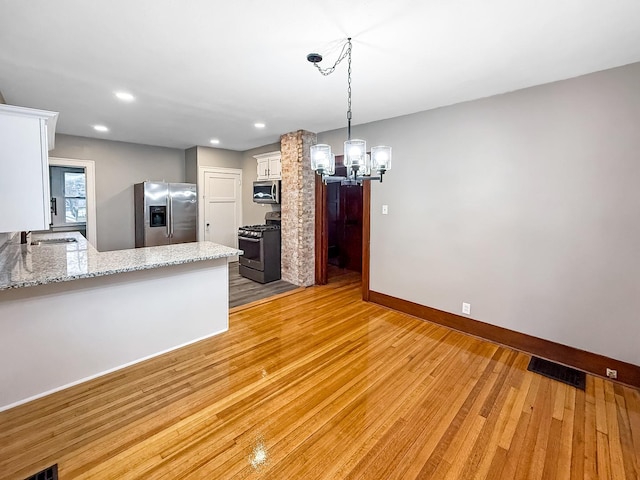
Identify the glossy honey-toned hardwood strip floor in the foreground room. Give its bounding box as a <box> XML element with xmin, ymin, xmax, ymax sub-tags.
<box><xmin>0</xmin><ymin>275</ymin><xmax>640</xmax><ymax>480</ymax></box>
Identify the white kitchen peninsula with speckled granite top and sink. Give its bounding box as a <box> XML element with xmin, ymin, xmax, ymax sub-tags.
<box><xmin>0</xmin><ymin>233</ymin><xmax>241</xmax><ymax>410</ymax></box>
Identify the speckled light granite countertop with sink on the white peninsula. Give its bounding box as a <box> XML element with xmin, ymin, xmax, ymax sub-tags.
<box><xmin>0</xmin><ymin>232</ymin><xmax>242</xmax><ymax>290</ymax></box>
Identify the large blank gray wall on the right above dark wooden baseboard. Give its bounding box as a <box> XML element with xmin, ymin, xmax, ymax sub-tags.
<box><xmin>318</xmin><ymin>64</ymin><xmax>640</xmax><ymax>368</ymax></box>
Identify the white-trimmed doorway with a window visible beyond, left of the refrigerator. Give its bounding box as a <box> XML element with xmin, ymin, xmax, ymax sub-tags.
<box><xmin>49</xmin><ymin>157</ymin><xmax>98</xmax><ymax>249</ymax></box>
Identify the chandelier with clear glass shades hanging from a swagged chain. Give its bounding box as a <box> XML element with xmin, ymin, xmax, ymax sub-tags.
<box><xmin>307</xmin><ymin>38</ymin><xmax>391</xmax><ymax>185</ymax></box>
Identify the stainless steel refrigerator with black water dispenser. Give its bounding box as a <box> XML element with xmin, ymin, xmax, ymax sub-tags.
<box><xmin>133</xmin><ymin>182</ymin><xmax>198</xmax><ymax>248</ymax></box>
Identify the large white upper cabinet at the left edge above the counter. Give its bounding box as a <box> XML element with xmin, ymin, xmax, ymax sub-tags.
<box><xmin>0</xmin><ymin>105</ymin><xmax>58</xmax><ymax>232</ymax></box>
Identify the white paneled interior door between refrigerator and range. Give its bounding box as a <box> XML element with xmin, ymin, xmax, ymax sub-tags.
<box><xmin>203</xmin><ymin>169</ymin><xmax>242</xmax><ymax>260</ymax></box>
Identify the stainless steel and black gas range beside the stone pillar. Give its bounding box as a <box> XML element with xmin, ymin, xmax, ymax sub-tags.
<box><xmin>238</xmin><ymin>212</ymin><xmax>280</xmax><ymax>283</ymax></box>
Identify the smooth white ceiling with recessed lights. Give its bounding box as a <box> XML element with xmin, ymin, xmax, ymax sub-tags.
<box><xmin>0</xmin><ymin>0</ymin><xmax>640</xmax><ymax>150</ymax></box>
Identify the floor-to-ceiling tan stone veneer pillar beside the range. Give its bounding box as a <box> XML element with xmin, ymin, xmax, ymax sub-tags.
<box><xmin>280</xmin><ymin>130</ymin><xmax>316</xmax><ymax>287</ymax></box>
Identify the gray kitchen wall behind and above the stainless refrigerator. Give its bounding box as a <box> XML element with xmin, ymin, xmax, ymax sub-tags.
<box><xmin>49</xmin><ymin>134</ymin><xmax>185</xmax><ymax>251</ymax></box>
